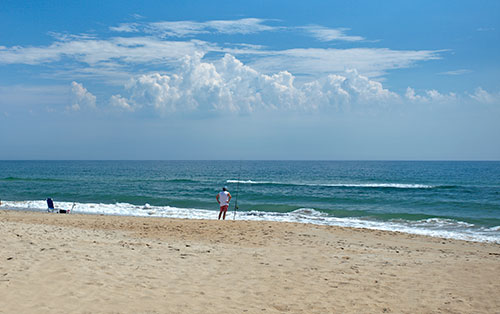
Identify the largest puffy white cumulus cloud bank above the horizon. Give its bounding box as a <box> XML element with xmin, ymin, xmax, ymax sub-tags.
<box><xmin>111</xmin><ymin>54</ymin><xmax>399</xmax><ymax>114</ymax></box>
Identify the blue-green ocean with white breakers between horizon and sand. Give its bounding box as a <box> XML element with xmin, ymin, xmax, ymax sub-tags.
<box><xmin>0</xmin><ymin>161</ymin><xmax>500</xmax><ymax>243</ymax></box>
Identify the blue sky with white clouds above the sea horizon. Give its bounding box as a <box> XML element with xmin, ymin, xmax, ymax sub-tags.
<box><xmin>0</xmin><ymin>0</ymin><xmax>500</xmax><ymax>160</ymax></box>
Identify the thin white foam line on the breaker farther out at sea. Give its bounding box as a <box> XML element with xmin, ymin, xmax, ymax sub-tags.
<box><xmin>226</xmin><ymin>180</ymin><xmax>435</xmax><ymax>189</ymax></box>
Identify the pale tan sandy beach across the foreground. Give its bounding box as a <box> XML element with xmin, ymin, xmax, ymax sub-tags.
<box><xmin>0</xmin><ymin>210</ymin><xmax>500</xmax><ymax>313</ymax></box>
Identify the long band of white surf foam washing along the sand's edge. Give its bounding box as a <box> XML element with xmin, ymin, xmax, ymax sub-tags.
<box><xmin>0</xmin><ymin>200</ymin><xmax>500</xmax><ymax>243</ymax></box>
